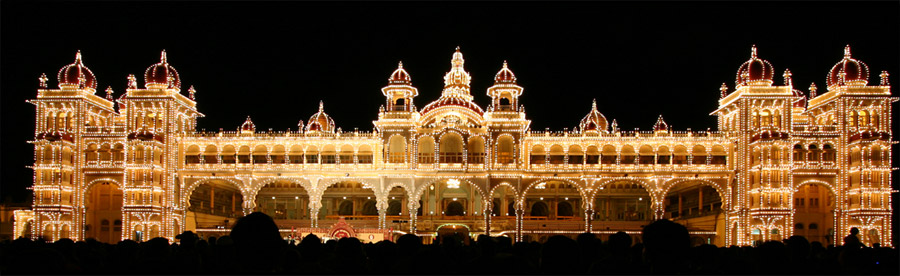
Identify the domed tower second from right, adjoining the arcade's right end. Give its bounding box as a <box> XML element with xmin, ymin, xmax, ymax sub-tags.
<box><xmin>713</xmin><ymin>45</ymin><xmax>796</xmax><ymax>245</ymax></box>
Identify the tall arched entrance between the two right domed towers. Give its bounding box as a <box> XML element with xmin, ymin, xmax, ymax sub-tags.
<box><xmin>793</xmin><ymin>182</ymin><xmax>835</xmax><ymax>246</ymax></box>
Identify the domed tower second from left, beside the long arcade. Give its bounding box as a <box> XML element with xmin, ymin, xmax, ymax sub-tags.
<box><xmin>119</xmin><ymin>50</ymin><xmax>203</xmax><ymax>240</ymax></box>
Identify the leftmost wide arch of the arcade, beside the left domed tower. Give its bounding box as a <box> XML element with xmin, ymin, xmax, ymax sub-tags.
<box><xmin>184</xmin><ymin>179</ymin><xmax>244</xmax><ymax>230</ymax></box>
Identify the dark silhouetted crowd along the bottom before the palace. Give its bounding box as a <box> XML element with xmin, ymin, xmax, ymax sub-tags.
<box><xmin>0</xmin><ymin>212</ymin><xmax>900</xmax><ymax>275</ymax></box>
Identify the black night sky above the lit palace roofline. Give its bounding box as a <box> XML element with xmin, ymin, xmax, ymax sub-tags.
<box><xmin>0</xmin><ymin>1</ymin><xmax>900</xmax><ymax>212</ymax></box>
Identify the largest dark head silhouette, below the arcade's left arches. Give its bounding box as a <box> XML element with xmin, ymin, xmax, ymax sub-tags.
<box><xmin>231</xmin><ymin>212</ymin><xmax>287</xmax><ymax>274</ymax></box>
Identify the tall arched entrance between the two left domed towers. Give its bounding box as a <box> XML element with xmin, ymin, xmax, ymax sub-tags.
<box><xmin>84</xmin><ymin>181</ymin><xmax>123</xmax><ymax>243</ymax></box>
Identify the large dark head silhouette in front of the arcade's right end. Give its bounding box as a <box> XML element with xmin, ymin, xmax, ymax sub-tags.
<box><xmin>641</xmin><ymin>219</ymin><xmax>691</xmax><ymax>274</ymax></box>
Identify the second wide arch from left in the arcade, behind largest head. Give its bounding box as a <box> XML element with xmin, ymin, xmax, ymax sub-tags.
<box><xmin>255</xmin><ymin>179</ymin><xmax>309</xmax><ymax>220</ymax></box>
